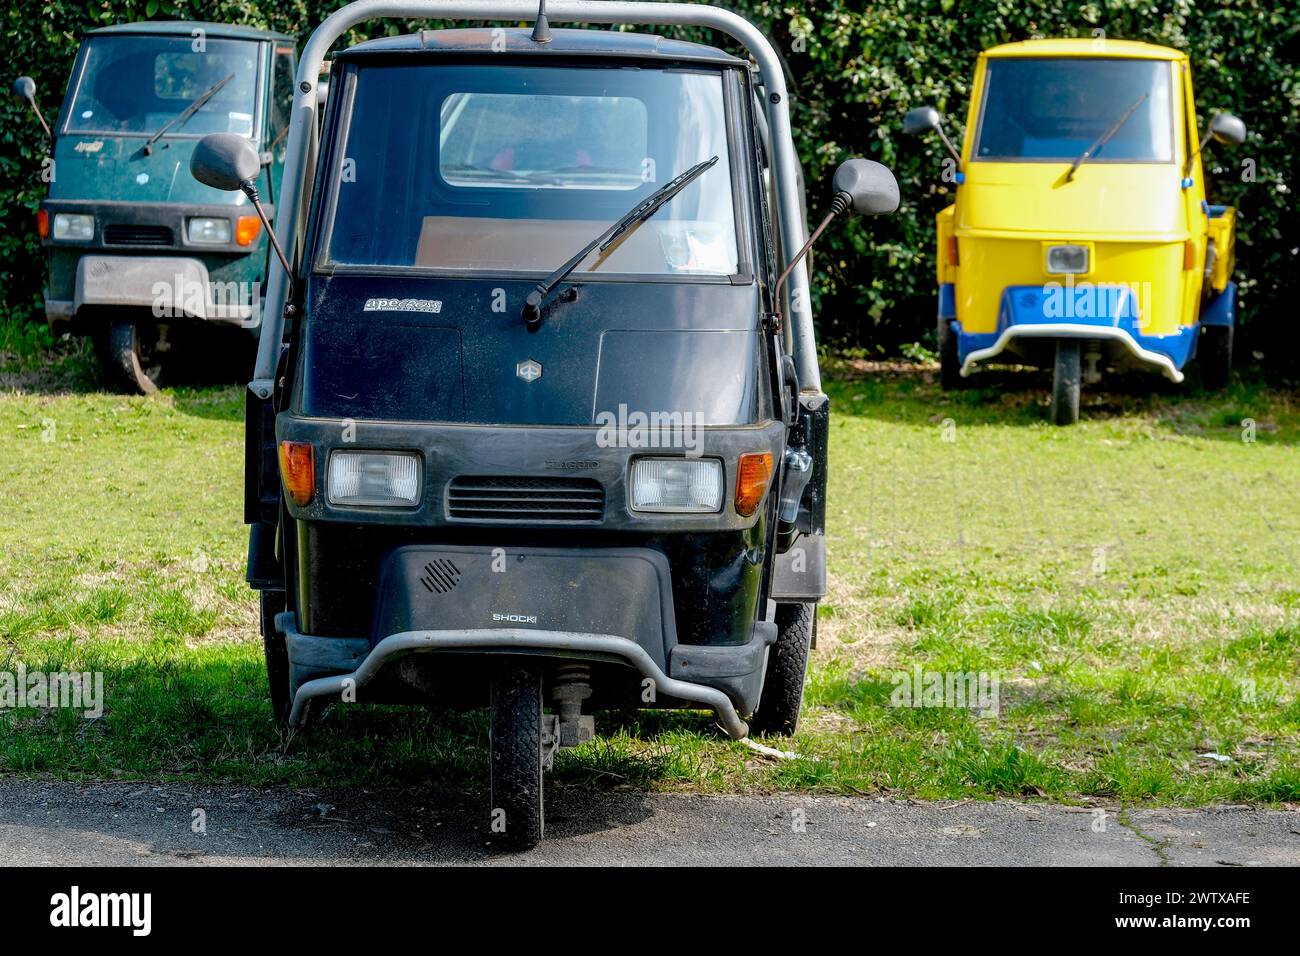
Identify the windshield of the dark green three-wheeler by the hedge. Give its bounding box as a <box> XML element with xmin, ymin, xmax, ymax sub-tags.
<box><xmin>64</xmin><ymin>35</ymin><xmax>257</xmax><ymax>137</ymax></box>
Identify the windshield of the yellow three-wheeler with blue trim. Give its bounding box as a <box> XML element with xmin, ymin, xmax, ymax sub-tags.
<box><xmin>974</xmin><ymin>57</ymin><xmax>1174</xmax><ymax>163</ymax></box>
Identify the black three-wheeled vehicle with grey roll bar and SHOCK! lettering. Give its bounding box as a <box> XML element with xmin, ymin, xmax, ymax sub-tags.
<box><xmin>192</xmin><ymin>0</ymin><xmax>898</xmax><ymax>848</ymax></box>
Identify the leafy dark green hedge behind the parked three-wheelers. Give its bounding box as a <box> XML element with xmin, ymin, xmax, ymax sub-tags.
<box><xmin>0</xmin><ymin>0</ymin><xmax>1300</xmax><ymax>372</ymax></box>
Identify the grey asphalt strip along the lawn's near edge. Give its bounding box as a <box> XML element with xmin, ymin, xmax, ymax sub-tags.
<box><xmin>0</xmin><ymin>778</ymin><xmax>1300</xmax><ymax>866</ymax></box>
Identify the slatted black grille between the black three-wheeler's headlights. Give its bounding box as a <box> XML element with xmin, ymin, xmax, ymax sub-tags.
<box><xmin>447</xmin><ymin>476</ymin><xmax>605</xmax><ymax>522</ymax></box>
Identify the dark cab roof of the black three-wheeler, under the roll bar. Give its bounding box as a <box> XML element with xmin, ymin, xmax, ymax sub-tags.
<box><xmin>337</xmin><ymin>27</ymin><xmax>745</xmax><ymax>66</ymax></box>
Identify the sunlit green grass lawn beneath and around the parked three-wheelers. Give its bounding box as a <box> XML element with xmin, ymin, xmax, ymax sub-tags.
<box><xmin>0</xmin><ymin>354</ymin><xmax>1300</xmax><ymax>804</ymax></box>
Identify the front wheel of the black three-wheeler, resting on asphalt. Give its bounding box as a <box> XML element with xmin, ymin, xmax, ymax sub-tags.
<box><xmin>489</xmin><ymin>659</ymin><xmax>543</xmax><ymax>851</ymax></box>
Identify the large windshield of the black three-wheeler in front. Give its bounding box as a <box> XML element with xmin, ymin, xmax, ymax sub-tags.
<box><xmin>328</xmin><ymin>65</ymin><xmax>738</xmax><ymax>276</ymax></box>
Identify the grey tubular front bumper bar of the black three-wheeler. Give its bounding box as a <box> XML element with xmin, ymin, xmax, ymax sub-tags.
<box><xmin>276</xmin><ymin>611</ymin><xmax>759</xmax><ymax>740</ymax></box>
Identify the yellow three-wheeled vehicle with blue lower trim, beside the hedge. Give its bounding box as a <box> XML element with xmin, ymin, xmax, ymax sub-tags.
<box><xmin>904</xmin><ymin>39</ymin><xmax>1245</xmax><ymax>424</ymax></box>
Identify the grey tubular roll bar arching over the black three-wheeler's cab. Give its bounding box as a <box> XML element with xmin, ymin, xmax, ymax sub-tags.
<box><xmin>250</xmin><ymin>0</ymin><xmax>822</xmax><ymax>397</ymax></box>
